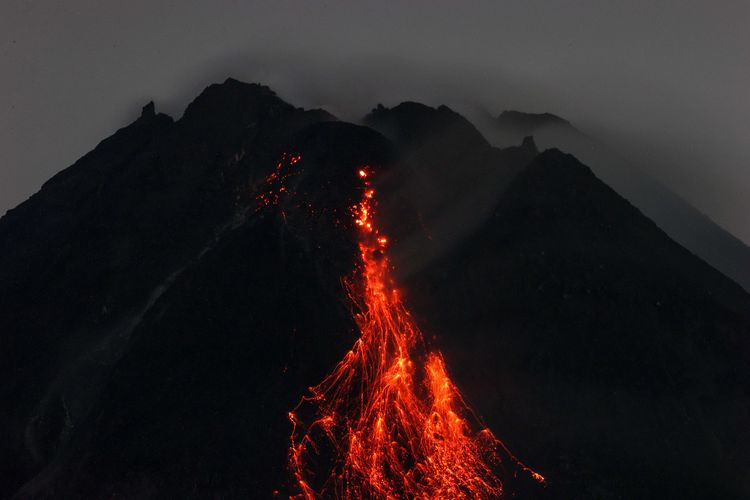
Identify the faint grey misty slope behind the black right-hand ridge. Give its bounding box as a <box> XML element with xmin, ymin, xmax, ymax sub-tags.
<box><xmin>485</xmin><ymin>107</ymin><xmax>750</xmax><ymax>290</ymax></box>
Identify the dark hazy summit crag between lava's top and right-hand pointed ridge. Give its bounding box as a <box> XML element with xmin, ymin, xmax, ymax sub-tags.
<box><xmin>364</xmin><ymin>102</ymin><xmax>538</xmax><ymax>278</ymax></box>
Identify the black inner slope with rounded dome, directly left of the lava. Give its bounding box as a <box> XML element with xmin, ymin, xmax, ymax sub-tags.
<box><xmin>14</xmin><ymin>124</ymin><xmax>396</xmax><ymax>498</ymax></box>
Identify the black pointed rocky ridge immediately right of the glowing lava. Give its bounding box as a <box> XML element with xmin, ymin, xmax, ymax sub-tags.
<box><xmin>406</xmin><ymin>150</ymin><xmax>750</xmax><ymax>499</ymax></box>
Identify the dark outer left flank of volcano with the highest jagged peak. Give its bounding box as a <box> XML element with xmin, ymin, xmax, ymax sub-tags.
<box><xmin>0</xmin><ymin>79</ymin><xmax>338</xmax><ymax>491</ymax></box>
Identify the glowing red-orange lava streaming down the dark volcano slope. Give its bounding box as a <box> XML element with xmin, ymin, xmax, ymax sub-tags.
<box><xmin>261</xmin><ymin>157</ymin><xmax>544</xmax><ymax>499</ymax></box>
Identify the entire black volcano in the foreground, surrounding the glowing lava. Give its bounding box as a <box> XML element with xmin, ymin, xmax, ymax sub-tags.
<box><xmin>0</xmin><ymin>79</ymin><xmax>750</xmax><ymax>498</ymax></box>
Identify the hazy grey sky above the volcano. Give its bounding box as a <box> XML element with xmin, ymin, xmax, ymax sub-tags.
<box><xmin>0</xmin><ymin>0</ymin><xmax>750</xmax><ymax>242</ymax></box>
